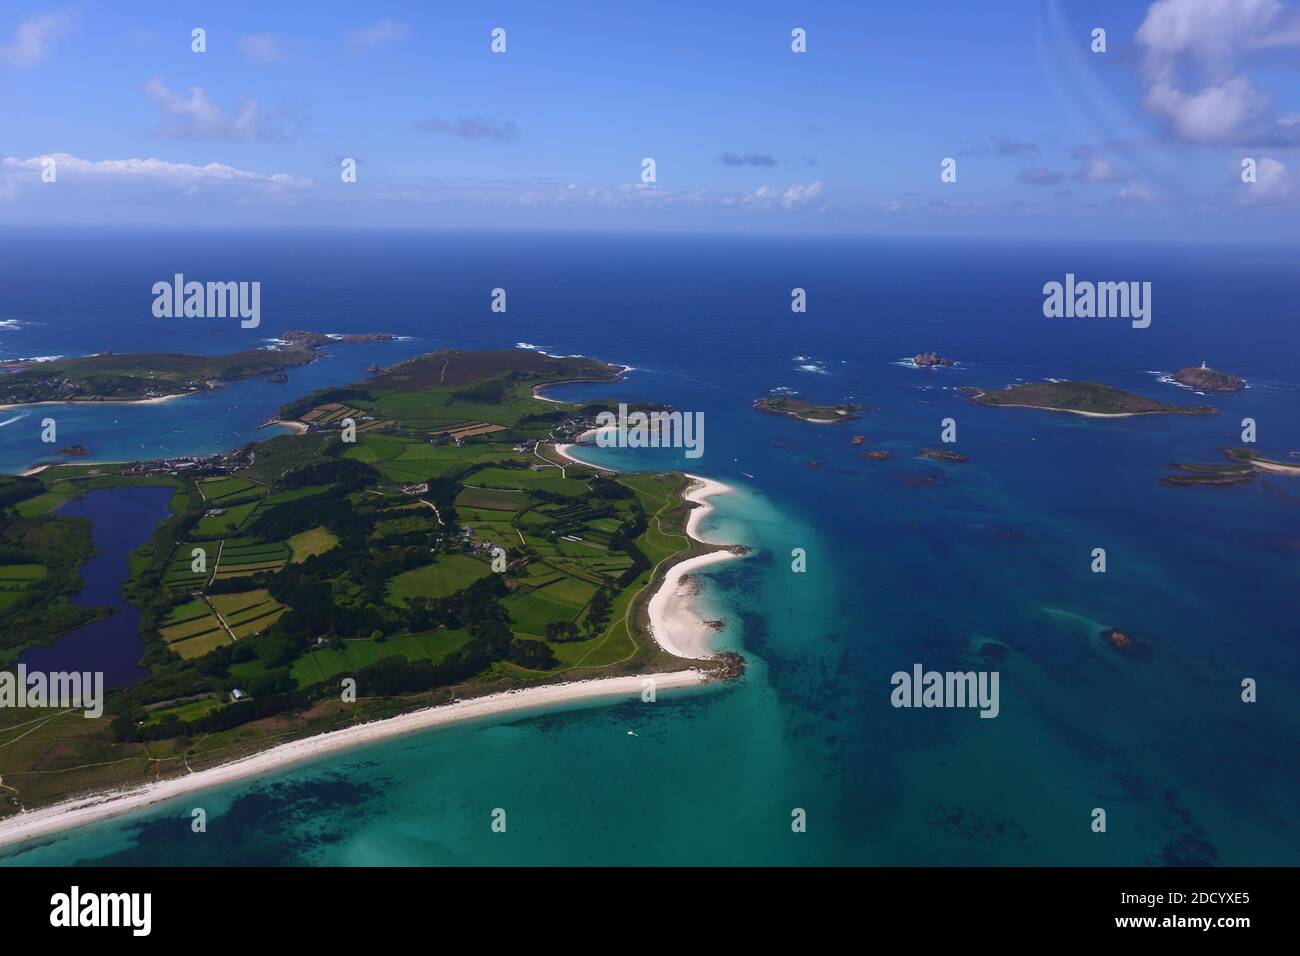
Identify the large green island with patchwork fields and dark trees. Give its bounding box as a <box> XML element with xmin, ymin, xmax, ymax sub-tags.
<box><xmin>0</xmin><ymin>350</ymin><xmax>742</xmax><ymax>817</ymax></box>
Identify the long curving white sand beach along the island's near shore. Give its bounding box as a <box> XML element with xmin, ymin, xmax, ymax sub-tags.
<box><xmin>0</xmin><ymin>670</ymin><xmax>705</xmax><ymax>847</ymax></box>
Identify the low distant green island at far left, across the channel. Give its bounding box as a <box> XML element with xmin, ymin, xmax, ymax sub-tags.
<box><xmin>0</xmin><ymin>332</ymin><xmax>393</xmax><ymax>407</ymax></box>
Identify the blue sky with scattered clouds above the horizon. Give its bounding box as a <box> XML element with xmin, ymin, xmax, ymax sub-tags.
<box><xmin>0</xmin><ymin>0</ymin><xmax>1300</xmax><ymax>241</ymax></box>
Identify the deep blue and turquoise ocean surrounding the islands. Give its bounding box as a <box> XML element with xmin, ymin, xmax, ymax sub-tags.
<box><xmin>0</xmin><ymin>230</ymin><xmax>1300</xmax><ymax>865</ymax></box>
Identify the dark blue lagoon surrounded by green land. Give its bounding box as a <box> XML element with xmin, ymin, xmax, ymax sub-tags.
<box><xmin>20</xmin><ymin>488</ymin><xmax>172</xmax><ymax>689</ymax></box>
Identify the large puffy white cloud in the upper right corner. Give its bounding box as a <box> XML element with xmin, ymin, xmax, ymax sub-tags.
<box><xmin>1135</xmin><ymin>0</ymin><xmax>1300</xmax><ymax>144</ymax></box>
